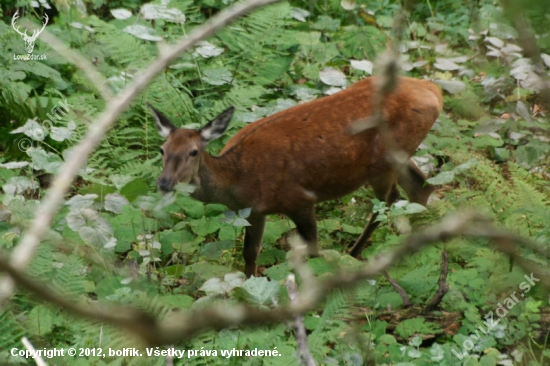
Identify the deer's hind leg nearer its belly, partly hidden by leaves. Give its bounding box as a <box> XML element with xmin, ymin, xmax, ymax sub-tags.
<box><xmin>350</xmin><ymin>174</ymin><xmax>399</xmax><ymax>258</ymax></box>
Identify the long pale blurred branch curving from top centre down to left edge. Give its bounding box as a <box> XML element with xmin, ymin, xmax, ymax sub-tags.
<box><xmin>0</xmin><ymin>0</ymin><xmax>277</xmax><ymax>305</ymax></box>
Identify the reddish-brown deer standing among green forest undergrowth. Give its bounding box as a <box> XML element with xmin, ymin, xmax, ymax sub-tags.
<box><xmin>149</xmin><ymin>77</ymin><xmax>443</xmax><ymax>277</ymax></box>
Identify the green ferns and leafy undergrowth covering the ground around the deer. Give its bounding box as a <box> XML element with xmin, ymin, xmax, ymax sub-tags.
<box><xmin>0</xmin><ymin>0</ymin><xmax>550</xmax><ymax>365</ymax></box>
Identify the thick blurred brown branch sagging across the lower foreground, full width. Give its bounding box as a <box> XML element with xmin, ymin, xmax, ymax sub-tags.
<box><xmin>0</xmin><ymin>212</ymin><xmax>550</xmax><ymax>345</ymax></box>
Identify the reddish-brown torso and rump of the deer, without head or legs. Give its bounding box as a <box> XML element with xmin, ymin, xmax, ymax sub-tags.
<box><xmin>208</xmin><ymin>77</ymin><xmax>443</xmax><ymax>213</ymax></box>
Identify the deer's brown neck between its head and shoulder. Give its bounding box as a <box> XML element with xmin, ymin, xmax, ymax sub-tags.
<box><xmin>191</xmin><ymin>152</ymin><xmax>242</xmax><ymax>209</ymax></box>
